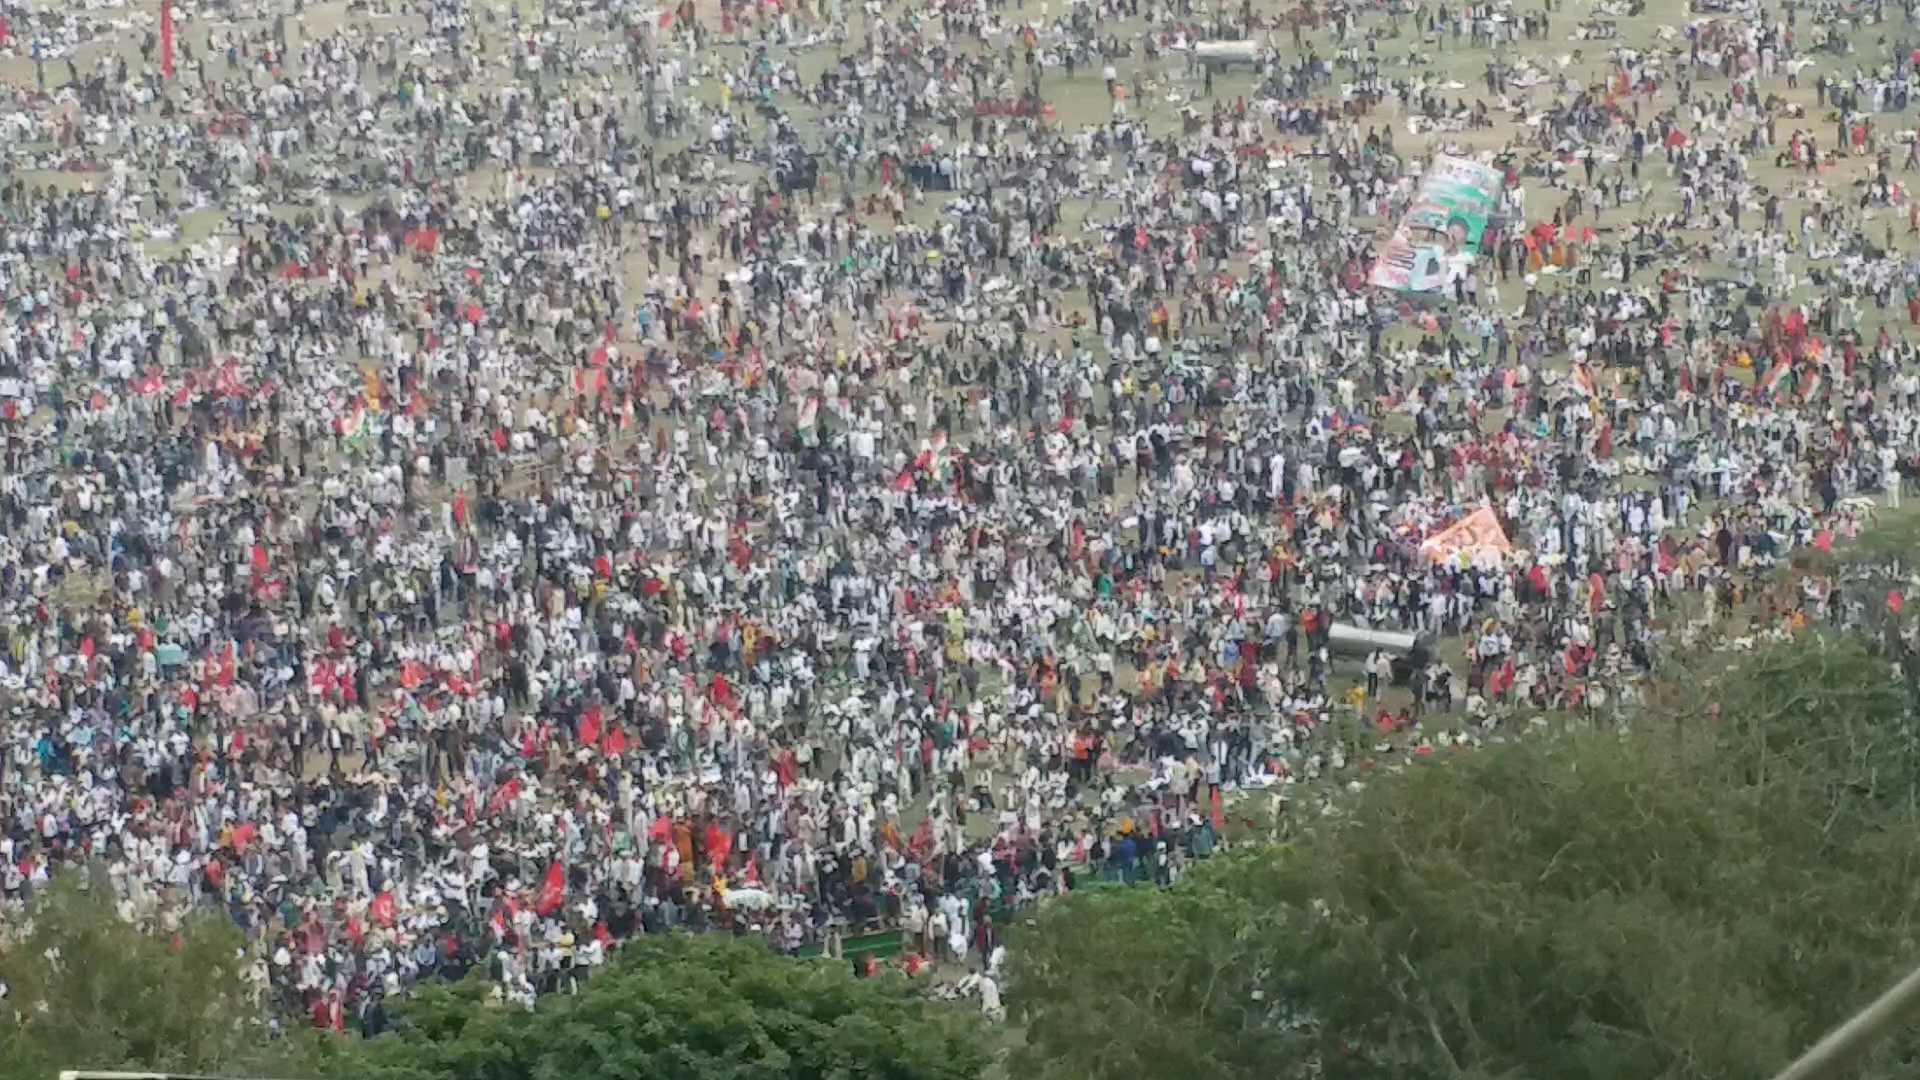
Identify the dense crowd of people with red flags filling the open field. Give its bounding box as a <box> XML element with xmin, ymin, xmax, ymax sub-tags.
<box><xmin>0</xmin><ymin>0</ymin><xmax>1920</xmax><ymax>1032</ymax></box>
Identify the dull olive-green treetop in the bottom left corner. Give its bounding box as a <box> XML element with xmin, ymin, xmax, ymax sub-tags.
<box><xmin>0</xmin><ymin>876</ymin><xmax>261</xmax><ymax>1080</ymax></box>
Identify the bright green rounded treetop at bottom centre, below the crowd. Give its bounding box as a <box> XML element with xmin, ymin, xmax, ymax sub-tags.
<box><xmin>303</xmin><ymin>936</ymin><xmax>991</xmax><ymax>1080</ymax></box>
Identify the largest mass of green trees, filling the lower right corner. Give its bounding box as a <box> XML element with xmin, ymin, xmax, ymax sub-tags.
<box><xmin>1010</xmin><ymin>638</ymin><xmax>1920</xmax><ymax>1080</ymax></box>
